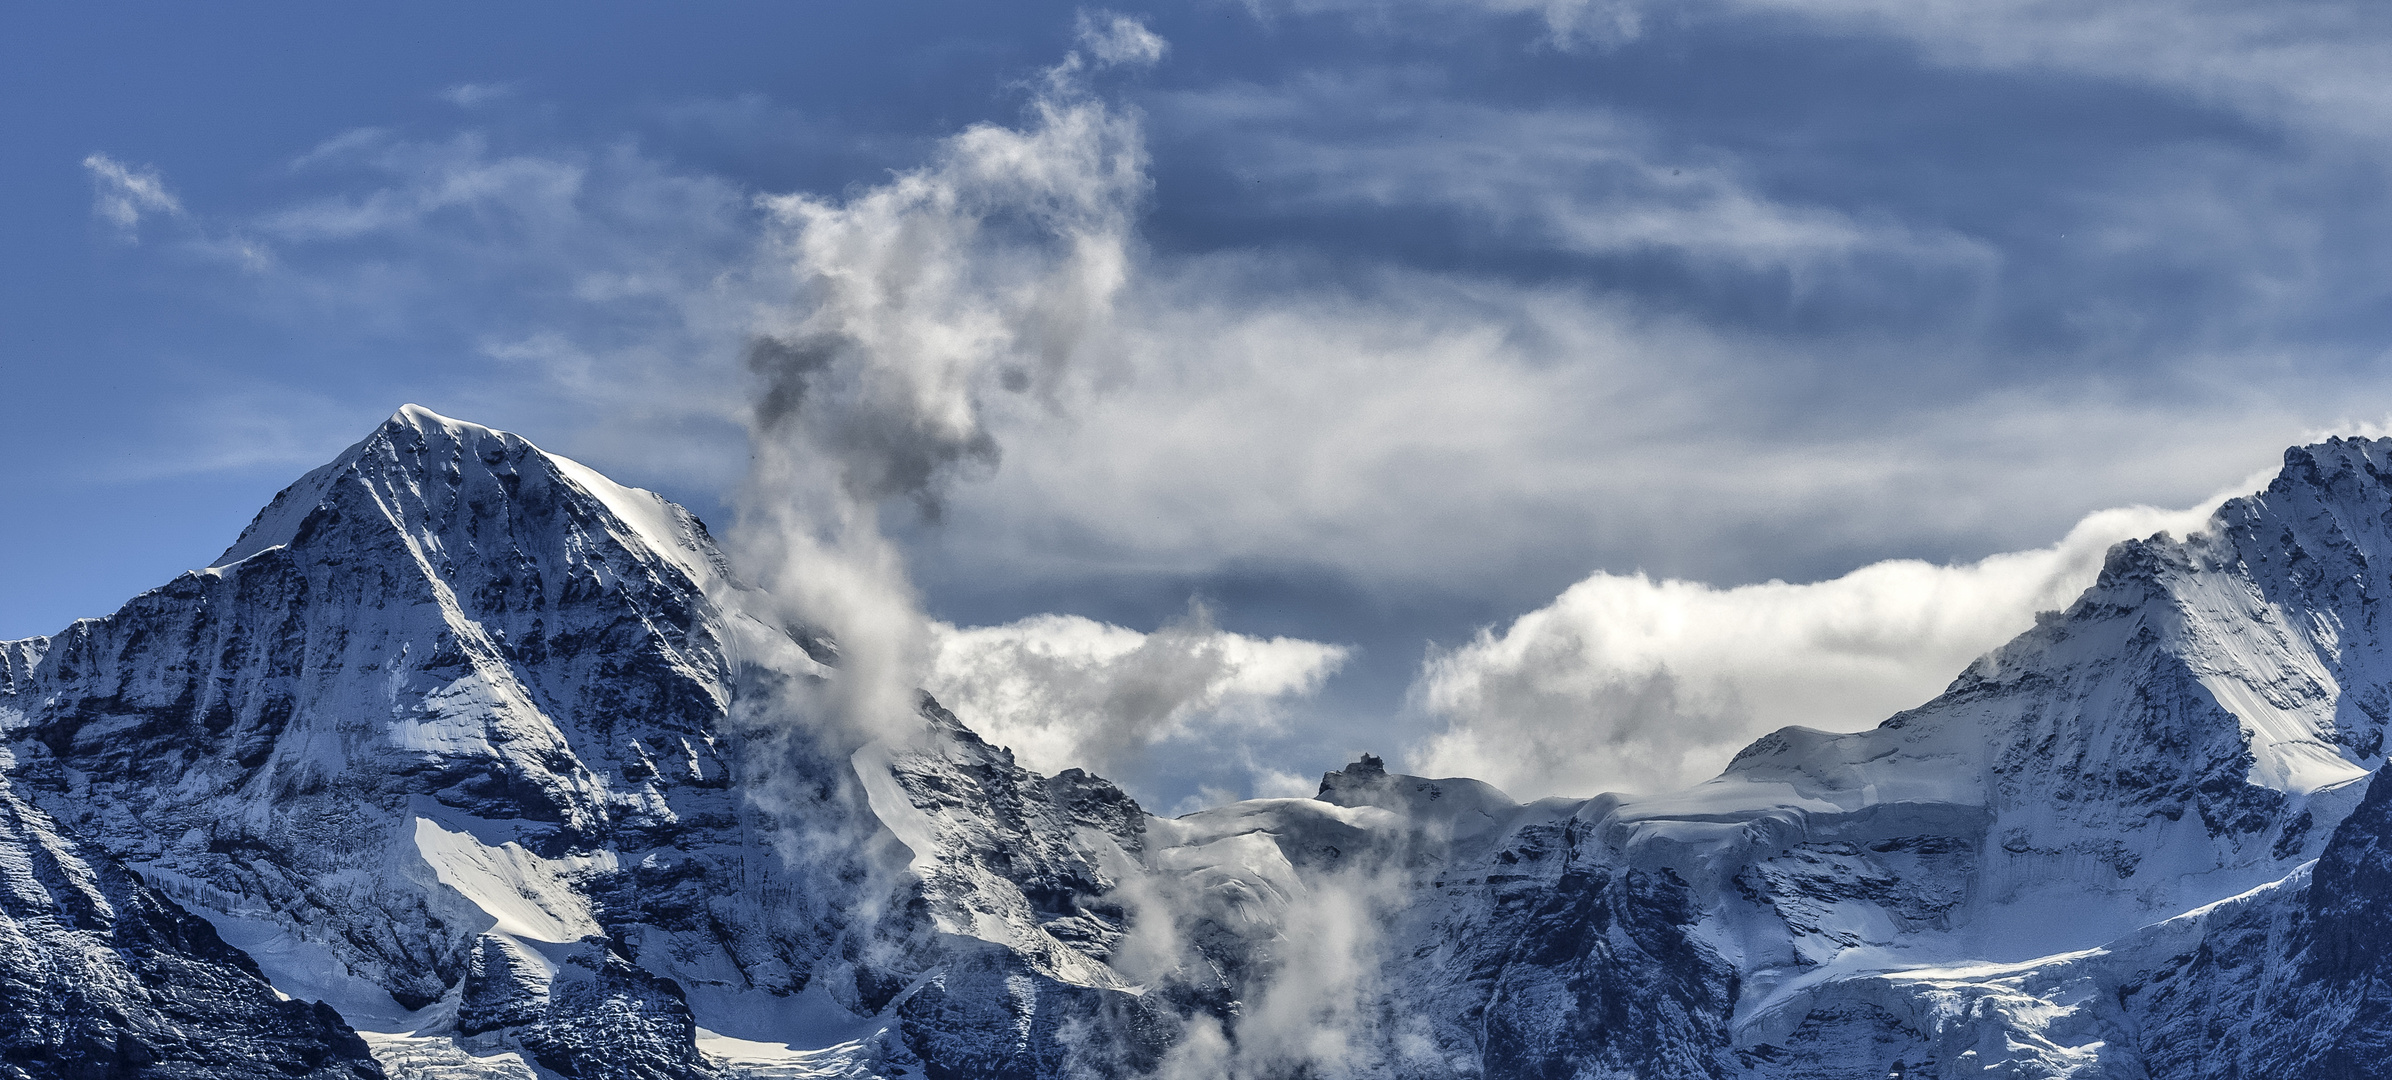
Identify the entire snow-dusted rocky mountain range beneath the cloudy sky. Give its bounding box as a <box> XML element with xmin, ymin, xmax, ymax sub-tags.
<box><xmin>0</xmin><ymin>406</ymin><xmax>2392</xmax><ymax>1080</ymax></box>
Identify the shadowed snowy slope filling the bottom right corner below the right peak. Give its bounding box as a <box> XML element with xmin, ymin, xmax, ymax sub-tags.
<box><xmin>1753</xmin><ymin>716</ymin><xmax>2392</xmax><ymax>1080</ymax></box>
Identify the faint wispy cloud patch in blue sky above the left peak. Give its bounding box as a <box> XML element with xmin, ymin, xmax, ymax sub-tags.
<box><xmin>218</xmin><ymin>129</ymin><xmax>765</xmax><ymax>490</ymax></box>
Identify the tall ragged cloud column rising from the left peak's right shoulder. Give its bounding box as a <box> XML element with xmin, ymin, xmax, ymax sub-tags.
<box><xmin>734</xmin><ymin>22</ymin><xmax>1160</xmax><ymax>738</ymax></box>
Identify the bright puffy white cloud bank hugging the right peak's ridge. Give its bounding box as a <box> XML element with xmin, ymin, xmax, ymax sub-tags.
<box><xmin>1409</xmin><ymin>480</ymin><xmax>2260</xmax><ymax>798</ymax></box>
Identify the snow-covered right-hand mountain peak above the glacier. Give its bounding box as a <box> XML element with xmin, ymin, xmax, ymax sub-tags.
<box><xmin>1550</xmin><ymin>440</ymin><xmax>2392</xmax><ymax>987</ymax></box>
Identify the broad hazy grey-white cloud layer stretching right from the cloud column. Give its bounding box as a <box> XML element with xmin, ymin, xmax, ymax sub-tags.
<box><xmin>916</xmin><ymin>258</ymin><xmax>2334</xmax><ymax>607</ymax></box>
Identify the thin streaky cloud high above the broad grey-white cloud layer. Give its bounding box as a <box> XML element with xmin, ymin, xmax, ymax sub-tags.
<box><xmin>1167</xmin><ymin>81</ymin><xmax>1997</xmax><ymax>280</ymax></box>
